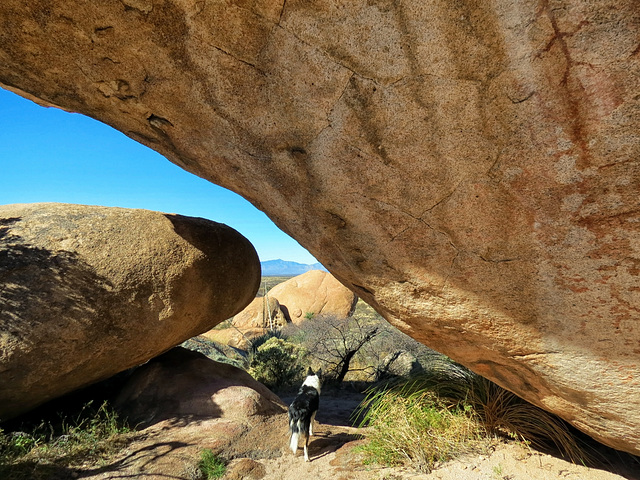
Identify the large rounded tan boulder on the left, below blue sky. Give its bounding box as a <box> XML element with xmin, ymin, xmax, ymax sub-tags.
<box><xmin>0</xmin><ymin>204</ymin><xmax>260</xmax><ymax>420</ymax></box>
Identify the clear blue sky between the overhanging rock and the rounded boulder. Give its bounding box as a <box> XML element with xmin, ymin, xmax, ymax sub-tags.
<box><xmin>0</xmin><ymin>89</ymin><xmax>316</xmax><ymax>263</ymax></box>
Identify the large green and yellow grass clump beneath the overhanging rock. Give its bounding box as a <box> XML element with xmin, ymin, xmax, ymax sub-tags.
<box><xmin>358</xmin><ymin>357</ymin><xmax>595</xmax><ymax>471</ymax></box>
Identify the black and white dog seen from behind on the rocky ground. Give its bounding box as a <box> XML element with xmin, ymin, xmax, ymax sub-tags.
<box><xmin>289</xmin><ymin>367</ymin><xmax>322</xmax><ymax>462</ymax></box>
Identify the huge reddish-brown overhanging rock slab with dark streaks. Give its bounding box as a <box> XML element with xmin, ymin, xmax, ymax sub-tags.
<box><xmin>0</xmin><ymin>0</ymin><xmax>640</xmax><ymax>453</ymax></box>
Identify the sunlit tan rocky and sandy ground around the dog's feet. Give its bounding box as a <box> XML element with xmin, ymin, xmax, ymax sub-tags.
<box><xmin>67</xmin><ymin>392</ymin><xmax>640</xmax><ymax>480</ymax></box>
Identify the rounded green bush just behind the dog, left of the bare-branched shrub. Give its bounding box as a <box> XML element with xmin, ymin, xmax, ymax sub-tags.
<box><xmin>247</xmin><ymin>337</ymin><xmax>305</xmax><ymax>388</ymax></box>
